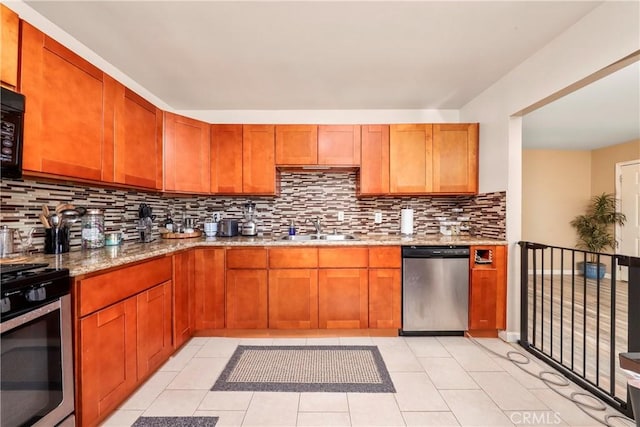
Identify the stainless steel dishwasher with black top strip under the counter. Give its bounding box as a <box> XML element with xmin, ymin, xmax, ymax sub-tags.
<box><xmin>400</xmin><ymin>246</ymin><xmax>469</xmax><ymax>335</ymax></box>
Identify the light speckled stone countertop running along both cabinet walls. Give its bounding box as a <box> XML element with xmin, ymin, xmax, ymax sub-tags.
<box><xmin>20</xmin><ymin>234</ymin><xmax>507</xmax><ymax>276</ymax></box>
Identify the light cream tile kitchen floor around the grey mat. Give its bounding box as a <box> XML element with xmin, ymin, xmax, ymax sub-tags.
<box><xmin>102</xmin><ymin>337</ymin><xmax>633</xmax><ymax>427</ymax></box>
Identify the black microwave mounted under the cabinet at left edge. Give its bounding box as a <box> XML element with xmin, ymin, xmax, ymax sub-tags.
<box><xmin>0</xmin><ymin>87</ymin><xmax>25</xmax><ymax>178</ymax></box>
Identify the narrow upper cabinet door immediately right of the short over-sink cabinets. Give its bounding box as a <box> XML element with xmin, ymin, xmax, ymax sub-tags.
<box><xmin>358</xmin><ymin>125</ymin><xmax>389</xmax><ymax>195</ymax></box>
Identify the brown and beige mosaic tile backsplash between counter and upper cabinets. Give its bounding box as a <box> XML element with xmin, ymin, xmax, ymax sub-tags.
<box><xmin>0</xmin><ymin>172</ymin><xmax>506</xmax><ymax>252</ymax></box>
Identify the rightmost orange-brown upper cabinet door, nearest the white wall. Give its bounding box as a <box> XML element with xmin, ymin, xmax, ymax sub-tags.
<box><xmin>433</xmin><ymin>123</ymin><xmax>478</xmax><ymax>194</ymax></box>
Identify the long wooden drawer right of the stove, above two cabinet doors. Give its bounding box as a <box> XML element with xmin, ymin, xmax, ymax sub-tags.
<box><xmin>75</xmin><ymin>257</ymin><xmax>172</xmax><ymax>317</ymax></box>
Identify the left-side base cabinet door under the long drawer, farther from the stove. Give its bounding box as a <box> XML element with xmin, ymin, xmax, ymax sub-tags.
<box><xmin>137</xmin><ymin>281</ymin><xmax>173</xmax><ymax>380</ymax></box>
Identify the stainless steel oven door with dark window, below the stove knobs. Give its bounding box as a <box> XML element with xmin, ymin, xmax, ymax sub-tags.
<box><xmin>0</xmin><ymin>295</ymin><xmax>73</xmax><ymax>427</ymax></box>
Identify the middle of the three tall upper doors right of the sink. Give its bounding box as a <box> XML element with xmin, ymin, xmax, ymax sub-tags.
<box><xmin>389</xmin><ymin>124</ymin><xmax>433</xmax><ymax>194</ymax></box>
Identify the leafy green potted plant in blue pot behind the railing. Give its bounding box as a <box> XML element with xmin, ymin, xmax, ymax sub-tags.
<box><xmin>571</xmin><ymin>193</ymin><xmax>627</xmax><ymax>279</ymax></box>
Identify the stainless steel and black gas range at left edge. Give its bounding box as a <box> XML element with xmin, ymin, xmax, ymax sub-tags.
<box><xmin>0</xmin><ymin>264</ymin><xmax>75</xmax><ymax>427</ymax></box>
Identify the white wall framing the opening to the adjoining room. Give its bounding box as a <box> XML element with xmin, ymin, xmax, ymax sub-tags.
<box><xmin>460</xmin><ymin>1</ymin><xmax>640</xmax><ymax>339</ymax></box>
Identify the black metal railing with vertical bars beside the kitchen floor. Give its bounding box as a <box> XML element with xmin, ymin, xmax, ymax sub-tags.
<box><xmin>519</xmin><ymin>242</ymin><xmax>640</xmax><ymax>416</ymax></box>
